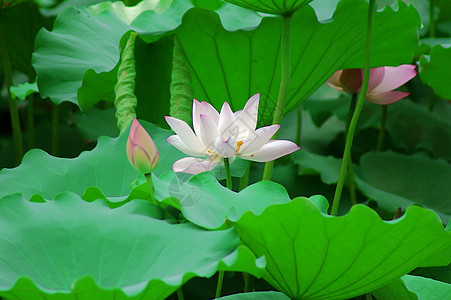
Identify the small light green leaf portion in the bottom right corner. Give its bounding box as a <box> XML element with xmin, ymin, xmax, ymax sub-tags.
<box><xmin>402</xmin><ymin>275</ymin><xmax>451</xmax><ymax>300</ymax></box>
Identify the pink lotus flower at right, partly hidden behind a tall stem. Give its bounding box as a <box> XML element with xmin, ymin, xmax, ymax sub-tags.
<box><xmin>327</xmin><ymin>65</ymin><xmax>417</xmax><ymax>105</ymax></box>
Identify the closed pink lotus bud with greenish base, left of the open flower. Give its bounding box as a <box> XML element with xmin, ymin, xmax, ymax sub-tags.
<box><xmin>127</xmin><ymin>118</ymin><xmax>159</xmax><ymax>174</ymax></box>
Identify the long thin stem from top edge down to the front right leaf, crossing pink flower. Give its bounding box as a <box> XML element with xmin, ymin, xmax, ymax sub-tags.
<box><xmin>331</xmin><ymin>0</ymin><xmax>376</xmax><ymax>216</ymax></box>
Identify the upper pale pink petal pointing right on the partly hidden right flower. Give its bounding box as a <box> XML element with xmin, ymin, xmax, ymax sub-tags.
<box><xmin>370</xmin><ymin>65</ymin><xmax>417</xmax><ymax>93</ymax></box>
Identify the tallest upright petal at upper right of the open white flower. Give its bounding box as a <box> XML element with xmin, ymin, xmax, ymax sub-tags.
<box><xmin>235</xmin><ymin>93</ymin><xmax>260</xmax><ymax>140</ymax></box>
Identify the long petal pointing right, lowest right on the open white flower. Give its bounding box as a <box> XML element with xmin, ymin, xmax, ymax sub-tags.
<box><xmin>239</xmin><ymin>140</ymin><xmax>301</xmax><ymax>162</ymax></box>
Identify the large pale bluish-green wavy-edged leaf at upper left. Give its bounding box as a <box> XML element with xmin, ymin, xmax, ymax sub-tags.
<box><xmin>33</xmin><ymin>1</ymin><xmax>191</xmax><ymax>109</ymax></box>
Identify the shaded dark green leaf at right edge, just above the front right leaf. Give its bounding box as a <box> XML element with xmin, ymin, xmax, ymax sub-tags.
<box><xmin>358</xmin><ymin>152</ymin><xmax>451</xmax><ymax>215</ymax></box>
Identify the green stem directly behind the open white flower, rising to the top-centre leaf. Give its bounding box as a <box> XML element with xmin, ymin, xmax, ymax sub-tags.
<box><xmin>262</xmin><ymin>14</ymin><xmax>292</xmax><ymax>180</ymax></box>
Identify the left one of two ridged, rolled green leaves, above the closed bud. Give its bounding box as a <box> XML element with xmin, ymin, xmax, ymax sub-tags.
<box><xmin>114</xmin><ymin>32</ymin><xmax>138</xmax><ymax>132</ymax></box>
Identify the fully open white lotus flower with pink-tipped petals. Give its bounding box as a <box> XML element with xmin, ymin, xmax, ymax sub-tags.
<box><xmin>165</xmin><ymin>94</ymin><xmax>300</xmax><ymax>174</ymax></box>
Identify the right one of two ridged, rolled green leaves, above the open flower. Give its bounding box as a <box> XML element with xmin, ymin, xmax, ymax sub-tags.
<box><xmin>170</xmin><ymin>37</ymin><xmax>194</xmax><ymax>124</ymax></box>
